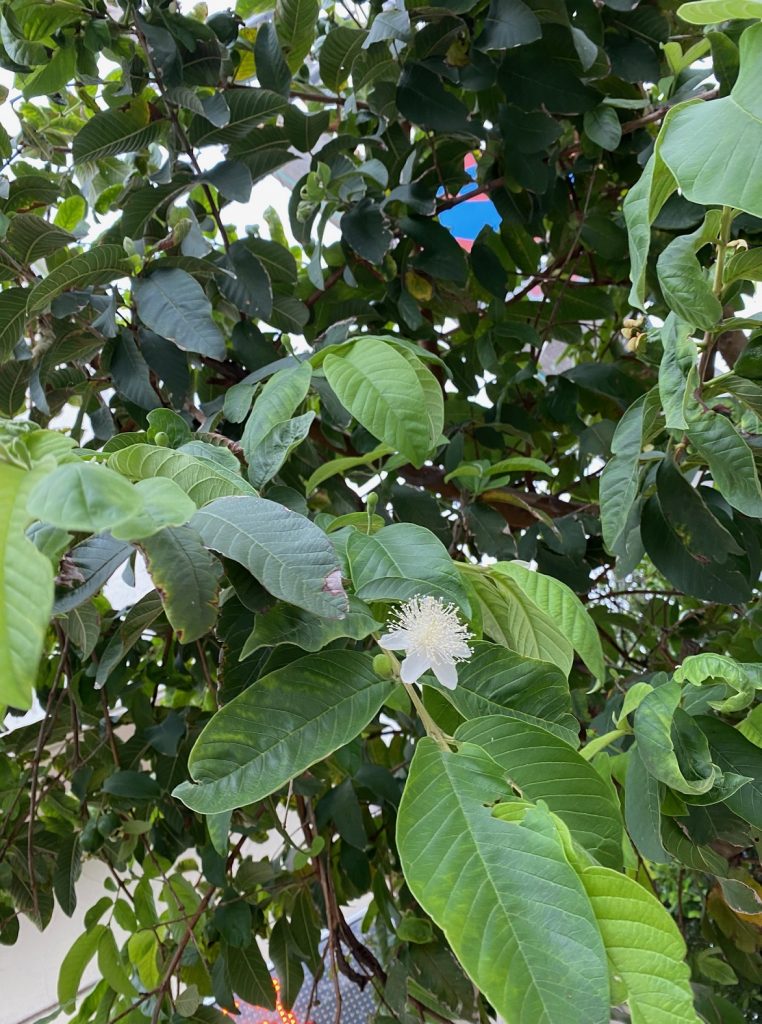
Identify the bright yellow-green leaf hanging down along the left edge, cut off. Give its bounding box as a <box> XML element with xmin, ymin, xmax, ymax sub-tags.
<box><xmin>0</xmin><ymin>462</ymin><xmax>53</xmax><ymax>711</ymax></box>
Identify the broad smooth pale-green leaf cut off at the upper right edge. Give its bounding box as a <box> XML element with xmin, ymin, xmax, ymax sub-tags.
<box><xmin>660</xmin><ymin>25</ymin><xmax>762</xmax><ymax>217</ymax></box>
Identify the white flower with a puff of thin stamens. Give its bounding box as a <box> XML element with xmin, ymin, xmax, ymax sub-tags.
<box><xmin>378</xmin><ymin>596</ymin><xmax>472</xmax><ymax>690</ymax></box>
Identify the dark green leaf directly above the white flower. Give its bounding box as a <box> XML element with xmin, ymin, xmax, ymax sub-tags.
<box><xmin>346</xmin><ymin>522</ymin><xmax>471</xmax><ymax>616</ymax></box>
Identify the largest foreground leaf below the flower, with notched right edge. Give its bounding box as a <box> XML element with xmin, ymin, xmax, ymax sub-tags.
<box><xmin>397</xmin><ymin>738</ymin><xmax>608</xmax><ymax>1024</ymax></box>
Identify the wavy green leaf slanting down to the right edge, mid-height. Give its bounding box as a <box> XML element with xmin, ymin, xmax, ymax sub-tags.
<box><xmin>683</xmin><ymin>368</ymin><xmax>762</xmax><ymax>517</ymax></box>
